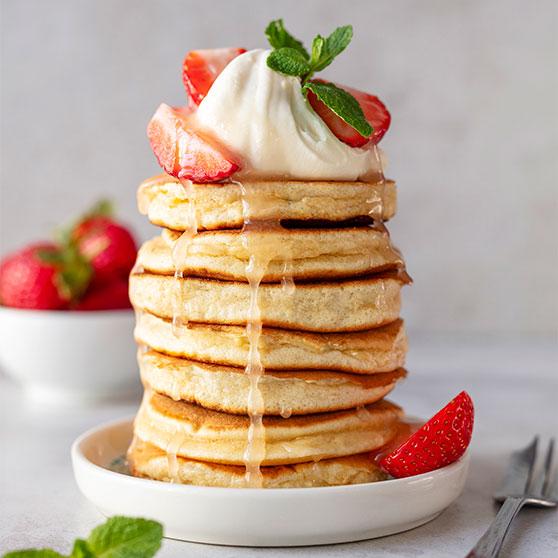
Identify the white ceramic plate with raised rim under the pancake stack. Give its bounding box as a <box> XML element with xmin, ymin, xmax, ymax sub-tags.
<box><xmin>72</xmin><ymin>419</ymin><xmax>469</xmax><ymax>546</ymax></box>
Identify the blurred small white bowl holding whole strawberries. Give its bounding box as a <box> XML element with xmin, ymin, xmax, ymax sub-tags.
<box><xmin>0</xmin><ymin>307</ymin><xmax>139</xmax><ymax>403</ymax></box>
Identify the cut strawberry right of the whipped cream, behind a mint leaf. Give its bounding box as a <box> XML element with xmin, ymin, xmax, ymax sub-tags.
<box><xmin>308</xmin><ymin>79</ymin><xmax>391</xmax><ymax>147</ymax></box>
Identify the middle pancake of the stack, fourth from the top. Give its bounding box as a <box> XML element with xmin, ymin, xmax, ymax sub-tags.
<box><xmin>135</xmin><ymin>312</ymin><xmax>407</xmax><ymax>374</ymax></box>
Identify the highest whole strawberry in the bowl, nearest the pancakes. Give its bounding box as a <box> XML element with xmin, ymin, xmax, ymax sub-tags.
<box><xmin>72</xmin><ymin>215</ymin><xmax>137</xmax><ymax>284</ymax></box>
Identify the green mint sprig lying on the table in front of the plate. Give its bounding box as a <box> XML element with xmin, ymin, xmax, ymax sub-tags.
<box><xmin>3</xmin><ymin>516</ymin><xmax>163</xmax><ymax>558</ymax></box>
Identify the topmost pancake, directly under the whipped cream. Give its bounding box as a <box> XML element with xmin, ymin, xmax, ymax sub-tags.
<box><xmin>137</xmin><ymin>175</ymin><xmax>396</xmax><ymax>231</ymax></box>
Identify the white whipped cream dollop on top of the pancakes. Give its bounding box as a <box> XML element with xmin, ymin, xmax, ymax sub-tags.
<box><xmin>196</xmin><ymin>50</ymin><xmax>384</xmax><ymax>180</ymax></box>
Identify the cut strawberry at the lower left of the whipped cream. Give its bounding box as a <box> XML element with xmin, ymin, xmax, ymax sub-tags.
<box><xmin>147</xmin><ymin>103</ymin><xmax>238</xmax><ymax>182</ymax></box>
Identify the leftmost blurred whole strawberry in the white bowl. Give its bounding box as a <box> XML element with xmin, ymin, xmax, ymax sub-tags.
<box><xmin>0</xmin><ymin>243</ymin><xmax>91</xmax><ymax>310</ymax></box>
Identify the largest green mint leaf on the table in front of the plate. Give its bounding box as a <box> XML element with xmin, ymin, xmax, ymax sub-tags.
<box><xmin>87</xmin><ymin>516</ymin><xmax>163</xmax><ymax>558</ymax></box>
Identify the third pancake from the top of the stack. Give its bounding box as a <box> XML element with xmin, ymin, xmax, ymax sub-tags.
<box><xmin>130</xmin><ymin>273</ymin><xmax>404</xmax><ymax>332</ymax></box>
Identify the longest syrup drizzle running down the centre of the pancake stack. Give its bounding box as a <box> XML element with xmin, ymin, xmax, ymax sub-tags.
<box><xmin>235</xmin><ymin>182</ymin><xmax>295</xmax><ymax>488</ymax></box>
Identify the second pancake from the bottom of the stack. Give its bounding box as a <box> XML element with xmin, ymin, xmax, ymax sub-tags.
<box><xmin>134</xmin><ymin>391</ymin><xmax>403</xmax><ymax>466</ymax></box>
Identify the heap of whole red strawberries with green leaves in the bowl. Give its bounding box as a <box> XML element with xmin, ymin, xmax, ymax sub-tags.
<box><xmin>0</xmin><ymin>201</ymin><xmax>136</xmax><ymax>316</ymax></box>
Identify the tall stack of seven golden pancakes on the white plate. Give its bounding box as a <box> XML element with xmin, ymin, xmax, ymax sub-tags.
<box><xmin>128</xmin><ymin>175</ymin><xmax>408</xmax><ymax>487</ymax></box>
